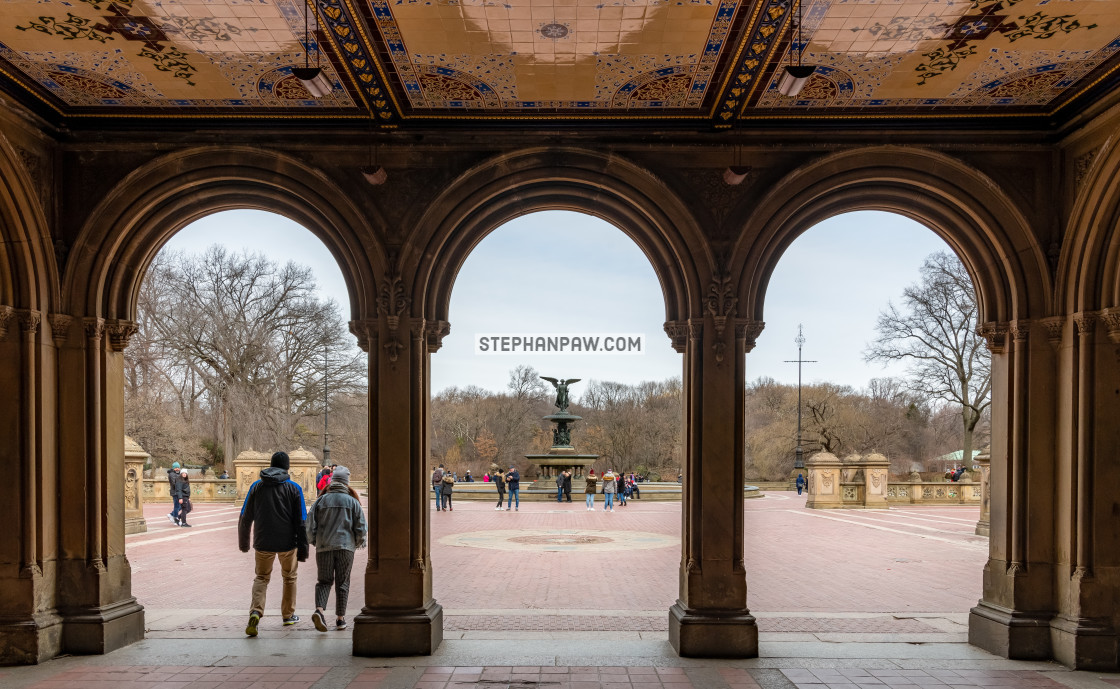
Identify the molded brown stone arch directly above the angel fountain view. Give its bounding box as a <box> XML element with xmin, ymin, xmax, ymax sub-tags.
<box><xmin>401</xmin><ymin>149</ymin><xmax>713</xmax><ymax>320</ymax></box>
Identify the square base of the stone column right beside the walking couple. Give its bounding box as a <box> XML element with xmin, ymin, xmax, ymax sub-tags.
<box><xmin>354</xmin><ymin>600</ymin><xmax>444</xmax><ymax>658</ymax></box>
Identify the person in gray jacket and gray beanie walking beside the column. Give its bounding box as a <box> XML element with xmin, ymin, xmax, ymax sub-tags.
<box><xmin>307</xmin><ymin>466</ymin><xmax>366</xmax><ymax>632</ymax></box>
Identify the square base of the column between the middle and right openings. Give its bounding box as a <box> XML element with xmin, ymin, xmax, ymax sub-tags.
<box><xmin>669</xmin><ymin>600</ymin><xmax>758</xmax><ymax>658</ymax></box>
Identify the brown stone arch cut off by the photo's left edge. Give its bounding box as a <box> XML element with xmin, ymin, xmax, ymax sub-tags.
<box><xmin>0</xmin><ymin>128</ymin><xmax>58</xmax><ymax>313</ymax></box>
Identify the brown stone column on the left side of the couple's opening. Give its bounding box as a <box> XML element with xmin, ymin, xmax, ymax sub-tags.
<box><xmin>58</xmin><ymin>317</ymin><xmax>144</xmax><ymax>654</ymax></box>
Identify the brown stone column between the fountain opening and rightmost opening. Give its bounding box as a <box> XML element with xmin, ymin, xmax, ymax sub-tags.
<box><xmin>665</xmin><ymin>295</ymin><xmax>763</xmax><ymax>658</ymax></box>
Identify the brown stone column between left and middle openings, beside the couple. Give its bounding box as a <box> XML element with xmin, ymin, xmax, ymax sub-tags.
<box><xmin>351</xmin><ymin>306</ymin><xmax>449</xmax><ymax>657</ymax></box>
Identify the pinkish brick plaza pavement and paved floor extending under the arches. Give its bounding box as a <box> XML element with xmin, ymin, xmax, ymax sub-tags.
<box><xmin>0</xmin><ymin>493</ymin><xmax>1120</xmax><ymax>689</ymax></box>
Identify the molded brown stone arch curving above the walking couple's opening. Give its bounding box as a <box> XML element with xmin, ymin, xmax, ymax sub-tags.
<box><xmin>63</xmin><ymin>147</ymin><xmax>385</xmax><ymax>320</ymax></box>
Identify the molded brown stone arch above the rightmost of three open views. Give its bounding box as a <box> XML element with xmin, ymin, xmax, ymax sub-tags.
<box><xmin>730</xmin><ymin>147</ymin><xmax>1052</xmax><ymax>323</ymax></box>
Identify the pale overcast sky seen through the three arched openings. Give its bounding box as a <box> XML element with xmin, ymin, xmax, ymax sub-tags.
<box><xmin>166</xmin><ymin>211</ymin><xmax>948</xmax><ymax>395</ymax></box>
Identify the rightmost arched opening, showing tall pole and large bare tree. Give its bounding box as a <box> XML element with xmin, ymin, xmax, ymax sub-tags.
<box><xmin>745</xmin><ymin>211</ymin><xmax>991</xmax><ymax>643</ymax></box>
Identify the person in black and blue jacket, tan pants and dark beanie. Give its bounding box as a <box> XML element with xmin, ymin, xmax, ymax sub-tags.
<box><xmin>237</xmin><ymin>453</ymin><xmax>308</xmax><ymax>636</ymax></box>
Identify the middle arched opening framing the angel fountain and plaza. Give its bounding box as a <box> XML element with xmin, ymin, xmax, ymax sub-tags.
<box><xmin>426</xmin><ymin>206</ymin><xmax>683</xmax><ymax>639</ymax></box>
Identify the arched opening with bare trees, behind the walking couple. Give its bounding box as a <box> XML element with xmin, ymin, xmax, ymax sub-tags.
<box><xmin>123</xmin><ymin>210</ymin><xmax>368</xmax><ymax>639</ymax></box>
